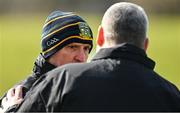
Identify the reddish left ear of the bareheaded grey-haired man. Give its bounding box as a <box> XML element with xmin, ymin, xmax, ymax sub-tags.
<box><xmin>96</xmin><ymin>26</ymin><xmax>104</xmax><ymax>47</ymax></box>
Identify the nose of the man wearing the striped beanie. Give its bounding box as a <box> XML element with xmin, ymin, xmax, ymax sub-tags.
<box><xmin>75</xmin><ymin>50</ymin><xmax>87</xmax><ymax>62</ymax></box>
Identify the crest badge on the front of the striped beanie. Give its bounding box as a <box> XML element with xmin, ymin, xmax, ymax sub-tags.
<box><xmin>79</xmin><ymin>22</ymin><xmax>92</xmax><ymax>38</ymax></box>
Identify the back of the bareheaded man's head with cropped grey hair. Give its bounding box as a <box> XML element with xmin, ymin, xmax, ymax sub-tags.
<box><xmin>102</xmin><ymin>2</ymin><xmax>148</xmax><ymax>48</ymax></box>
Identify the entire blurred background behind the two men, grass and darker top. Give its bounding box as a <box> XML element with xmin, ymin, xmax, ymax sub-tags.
<box><xmin>0</xmin><ymin>0</ymin><xmax>180</xmax><ymax>96</ymax></box>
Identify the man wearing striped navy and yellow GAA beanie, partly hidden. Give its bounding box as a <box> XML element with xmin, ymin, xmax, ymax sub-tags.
<box><xmin>0</xmin><ymin>11</ymin><xmax>93</xmax><ymax>111</ymax></box>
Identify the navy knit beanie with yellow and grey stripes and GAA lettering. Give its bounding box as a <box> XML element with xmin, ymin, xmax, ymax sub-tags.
<box><xmin>41</xmin><ymin>11</ymin><xmax>93</xmax><ymax>59</ymax></box>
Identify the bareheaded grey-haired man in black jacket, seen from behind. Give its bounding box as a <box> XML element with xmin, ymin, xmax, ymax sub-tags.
<box><xmin>9</xmin><ymin>2</ymin><xmax>180</xmax><ymax>113</ymax></box>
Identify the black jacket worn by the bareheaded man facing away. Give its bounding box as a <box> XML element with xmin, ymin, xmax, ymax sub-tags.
<box><xmin>16</xmin><ymin>44</ymin><xmax>180</xmax><ymax>112</ymax></box>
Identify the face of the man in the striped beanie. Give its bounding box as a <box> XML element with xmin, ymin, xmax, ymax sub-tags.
<box><xmin>48</xmin><ymin>43</ymin><xmax>91</xmax><ymax>66</ymax></box>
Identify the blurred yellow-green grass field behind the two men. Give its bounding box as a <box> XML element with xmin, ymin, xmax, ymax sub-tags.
<box><xmin>0</xmin><ymin>14</ymin><xmax>180</xmax><ymax>95</ymax></box>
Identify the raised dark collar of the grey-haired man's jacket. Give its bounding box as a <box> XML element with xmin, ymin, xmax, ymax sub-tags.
<box><xmin>92</xmin><ymin>44</ymin><xmax>155</xmax><ymax>70</ymax></box>
